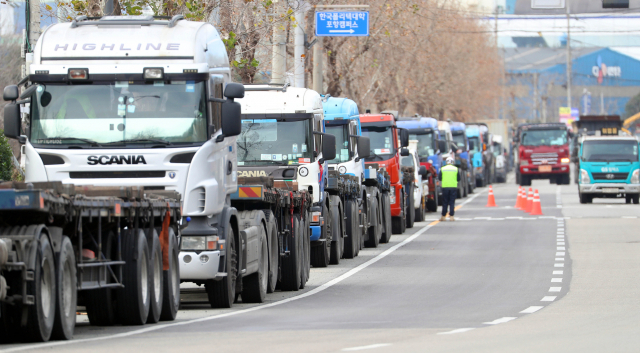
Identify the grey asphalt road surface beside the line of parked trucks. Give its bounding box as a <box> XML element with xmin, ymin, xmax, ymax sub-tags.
<box><xmin>0</xmin><ymin>172</ymin><xmax>640</xmax><ymax>352</ymax></box>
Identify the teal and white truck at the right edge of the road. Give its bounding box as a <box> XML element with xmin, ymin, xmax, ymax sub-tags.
<box><xmin>578</xmin><ymin>133</ymin><xmax>640</xmax><ymax>205</ymax></box>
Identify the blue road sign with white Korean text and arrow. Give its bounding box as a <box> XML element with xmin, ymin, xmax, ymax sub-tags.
<box><xmin>316</xmin><ymin>11</ymin><xmax>369</xmax><ymax>37</ymax></box>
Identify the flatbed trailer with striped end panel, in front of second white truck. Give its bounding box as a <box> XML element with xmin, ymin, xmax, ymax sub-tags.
<box><xmin>231</xmin><ymin>176</ymin><xmax>312</xmax><ymax>292</ymax></box>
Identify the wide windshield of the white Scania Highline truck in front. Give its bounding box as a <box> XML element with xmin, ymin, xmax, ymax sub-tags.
<box><xmin>30</xmin><ymin>81</ymin><xmax>207</xmax><ymax>148</ymax></box>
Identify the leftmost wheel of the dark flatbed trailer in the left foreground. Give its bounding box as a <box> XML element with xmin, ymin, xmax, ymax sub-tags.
<box><xmin>26</xmin><ymin>231</ymin><xmax>57</xmax><ymax>342</ymax></box>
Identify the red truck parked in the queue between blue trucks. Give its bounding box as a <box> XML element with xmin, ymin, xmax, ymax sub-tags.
<box><xmin>360</xmin><ymin>112</ymin><xmax>409</xmax><ymax>234</ymax></box>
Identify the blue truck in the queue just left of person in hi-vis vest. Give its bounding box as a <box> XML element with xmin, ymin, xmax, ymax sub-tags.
<box><xmin>398</xmin><ymin>117</ymin><xmax>444</xmax><ymax>212</ymax></box>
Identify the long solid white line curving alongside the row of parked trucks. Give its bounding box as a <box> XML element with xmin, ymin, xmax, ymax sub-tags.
<box><xmin>0</xmin><ymin>190</ymin><xmax>484</xmax><ymax>352</ymax></box>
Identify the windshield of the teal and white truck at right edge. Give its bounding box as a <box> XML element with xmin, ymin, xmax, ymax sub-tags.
<box><xmin>582</xmin><ymin>140</ymin><xmax>638</xmax><ymax>162</ymax></box>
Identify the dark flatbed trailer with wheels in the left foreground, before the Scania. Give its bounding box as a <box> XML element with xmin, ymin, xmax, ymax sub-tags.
<box><xmin>0</xmin><ymin>182</ymin><xmax>181</xmax><ymax>341</ymax></box>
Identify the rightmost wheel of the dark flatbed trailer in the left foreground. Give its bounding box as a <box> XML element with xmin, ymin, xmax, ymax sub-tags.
<box><xmin>156</xmin><ymin>227</ymin><xmax>180</xmax><ymax>321</ymax></box>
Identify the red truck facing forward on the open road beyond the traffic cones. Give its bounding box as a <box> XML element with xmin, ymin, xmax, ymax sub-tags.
<box><xmin>513</xmin><ymin>123</ymin><xmax>571</xmax><ymax>186</ymax></box>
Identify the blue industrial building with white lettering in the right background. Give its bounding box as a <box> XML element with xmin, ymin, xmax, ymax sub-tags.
<box><xmin>503</xmin><ymin>47</ymin><xmax>640</xmax><ymax>122</ymax></box>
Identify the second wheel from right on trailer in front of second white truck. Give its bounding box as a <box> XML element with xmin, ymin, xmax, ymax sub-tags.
<box><xmin>280</xmin><ymin>215</ymin><xmax>302</xmax><ymax>291</ymax></box>
